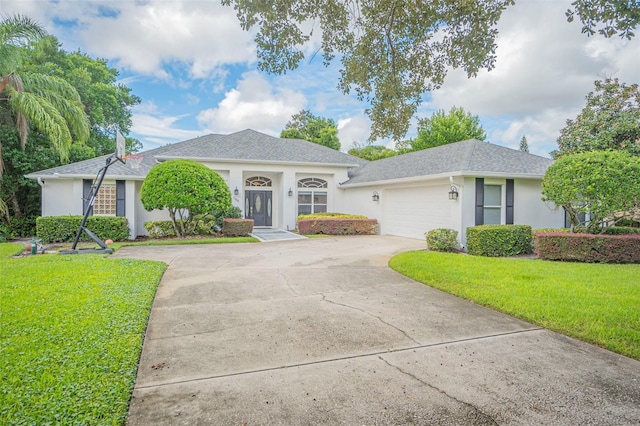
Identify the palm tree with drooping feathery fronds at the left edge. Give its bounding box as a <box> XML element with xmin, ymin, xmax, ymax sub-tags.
<box><xmin>0</xmin><ymin>15</ymin><xmax>89</xmax><ymax>177</ymax></box>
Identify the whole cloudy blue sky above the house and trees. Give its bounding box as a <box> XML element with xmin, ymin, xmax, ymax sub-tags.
<box><xmin>0</xmin><ymin>0</ymin><xmax>640</xmax><ymax>156</ymax></box>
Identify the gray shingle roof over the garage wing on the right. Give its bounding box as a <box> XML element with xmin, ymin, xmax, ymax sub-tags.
<box><xmin>344</xmin><ymin>139</ymin><xmax>553</xmax><ymax>186</ymax></box>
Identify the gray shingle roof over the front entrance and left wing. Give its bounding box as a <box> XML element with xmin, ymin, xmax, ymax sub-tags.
<box><xmin>27</xmin><ymin>129</ymin><xmax>367</xmax><ymax>179</ymax></box>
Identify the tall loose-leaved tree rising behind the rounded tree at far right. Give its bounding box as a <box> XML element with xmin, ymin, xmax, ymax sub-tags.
<box><xmin>552</xmin><ymin>78</ymin><xmax>640</xmax><ymax>158</ymax></box>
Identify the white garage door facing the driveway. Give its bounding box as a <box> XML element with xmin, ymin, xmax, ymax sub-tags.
<box><xmin>382</xmin><ymin>186</ymin><xmax>452</xmax><ymax>239</ymax></box>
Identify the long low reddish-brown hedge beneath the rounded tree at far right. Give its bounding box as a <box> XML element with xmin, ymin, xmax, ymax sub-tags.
<box><xmin>534</xmin><ymin>232</ymin><xmax>640</xmax><ymax>263</ymax></box>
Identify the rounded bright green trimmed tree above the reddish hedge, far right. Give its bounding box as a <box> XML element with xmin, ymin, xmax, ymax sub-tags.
<box><xmin>542</xmin><ymin>151</ymin><xmax>640</xmax><ymax>233</ymax></box>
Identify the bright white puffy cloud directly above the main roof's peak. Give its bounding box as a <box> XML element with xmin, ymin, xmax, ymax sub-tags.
<box><xmin>197</xmin><ymin>71</ymin><xmax>306</xmax><ymax>135</ymax></box>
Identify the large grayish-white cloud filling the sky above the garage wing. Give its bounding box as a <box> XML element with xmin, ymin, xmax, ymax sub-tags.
<box><xmin>424</xmin><ymin>1</ymin><xmax>640</xmax><ymax>156</ymax></box>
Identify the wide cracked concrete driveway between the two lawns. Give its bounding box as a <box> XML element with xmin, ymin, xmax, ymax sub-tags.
<box><xmin>114</xmin><ymin>236</ymin><xmax>640</xmax><ymax>425</ymax></box>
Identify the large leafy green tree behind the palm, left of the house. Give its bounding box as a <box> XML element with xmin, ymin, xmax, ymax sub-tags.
<box><xmin>0</xmin><ymin>36</ymin><xmax>141</xmax><ymax>236</ymax></box>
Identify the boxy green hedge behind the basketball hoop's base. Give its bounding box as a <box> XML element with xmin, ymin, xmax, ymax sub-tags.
<box><xmin>36</xmin><ymin>216</ymin><xmax>129</xmax><ymax>243</ymax></box>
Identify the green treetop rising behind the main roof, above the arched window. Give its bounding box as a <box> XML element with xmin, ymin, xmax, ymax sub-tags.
<box><xmin>280</xmin><ymin>109</ymin><xmax>340</xmax><ymax>150</ymax></box>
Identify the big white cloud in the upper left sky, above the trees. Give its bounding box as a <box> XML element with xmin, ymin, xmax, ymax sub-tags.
<box><xmin>3</xmin><ymin>0</ymin><xmax>255</xmax><ymax>80</ymax></box>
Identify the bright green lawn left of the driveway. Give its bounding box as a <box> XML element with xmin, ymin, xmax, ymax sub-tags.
<box><xmin>0</xmin><ymin>244</ymin><xmax>166</xmax><ymax>425</ymax></box>
